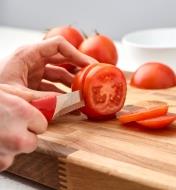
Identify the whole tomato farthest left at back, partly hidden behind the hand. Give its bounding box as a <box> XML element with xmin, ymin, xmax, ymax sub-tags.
<box><xmin>44</xmin><ymin>26</ymin><xmax>84</xmax><ymax>48</ymax></box>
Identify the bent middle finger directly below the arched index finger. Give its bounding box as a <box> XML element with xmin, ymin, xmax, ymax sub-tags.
<box><xmin>43</xmin><ymin>65</ymin><xmax>74</xmax><ymax>86</ymax></box>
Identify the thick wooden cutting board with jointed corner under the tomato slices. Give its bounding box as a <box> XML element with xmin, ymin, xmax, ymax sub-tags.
<box><xmin>9</xmin><ymin>74</ymin><xmax>176</xmax><ymax>190</ymax></box>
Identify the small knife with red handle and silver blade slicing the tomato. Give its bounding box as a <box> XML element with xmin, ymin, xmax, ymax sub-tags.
<box><xmin>31</xmin><ymin>91</ymin><xmax>85</xmax><ymax>122</ymax></box>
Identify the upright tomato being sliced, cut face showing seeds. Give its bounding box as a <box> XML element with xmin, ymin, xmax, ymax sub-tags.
<box><xmin>72</xmin><ymin>63</ymin><xmax>126</xmax><ymax>120</ymax></box>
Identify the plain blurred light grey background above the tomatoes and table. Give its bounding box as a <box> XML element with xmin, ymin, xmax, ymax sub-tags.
<box><xmin>0</xmin><ymin>0</ymin><xmax>176</xmax><ymax>40</ymax></box>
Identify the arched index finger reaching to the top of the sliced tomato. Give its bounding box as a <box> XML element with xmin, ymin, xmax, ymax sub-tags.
<box><xmin>33</xmin><ymin>36</ymin><xmax>97</xmax><ymax>67</ymax></box>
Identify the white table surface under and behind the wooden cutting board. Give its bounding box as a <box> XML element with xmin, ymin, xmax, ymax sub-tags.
<box><xmin>0</xmin><ymin>26</ymin><xmax>134</xmax><ymax>190</ymax></box>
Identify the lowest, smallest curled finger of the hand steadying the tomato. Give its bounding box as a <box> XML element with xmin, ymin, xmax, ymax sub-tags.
<box><xmin>39</xmin><ymin>81</ymin><xmax>65</xmax><ymax>94</ymax></box>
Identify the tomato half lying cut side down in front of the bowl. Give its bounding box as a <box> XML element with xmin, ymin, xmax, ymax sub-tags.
<box><xmin>130</xmin><ymin>62</ymin><xmax>176</xmax><ymax>89</ymax></box>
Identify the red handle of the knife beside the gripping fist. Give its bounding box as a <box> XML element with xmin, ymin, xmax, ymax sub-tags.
<box><xmin>31</xmin><ymin>96</ymin><xmax>56</xmax><ymax>122</ymax></box>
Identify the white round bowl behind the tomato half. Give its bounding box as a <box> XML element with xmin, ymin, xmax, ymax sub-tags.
<box><xmin>122</xmin><ymin>28</ymin><xmax>176</xmax><ymax>70</ymax></box>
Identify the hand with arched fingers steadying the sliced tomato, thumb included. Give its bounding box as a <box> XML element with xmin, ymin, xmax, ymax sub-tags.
<box><xmin>0</xmin><ymin>37</ymin><xmax>97</xmax><ymax>101</ymax></box>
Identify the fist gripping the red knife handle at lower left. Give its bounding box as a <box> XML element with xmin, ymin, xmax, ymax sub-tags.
<box><xmin>0</xmin><ymin>91</ymin><xmax>47</xmax><ymax>171</ymax></box>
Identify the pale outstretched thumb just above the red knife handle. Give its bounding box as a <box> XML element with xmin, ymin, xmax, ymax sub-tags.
<box><xmin>0</xmin><ymin>84</ymin><xmax>59</xmax><ymax>102</ymax></box>
